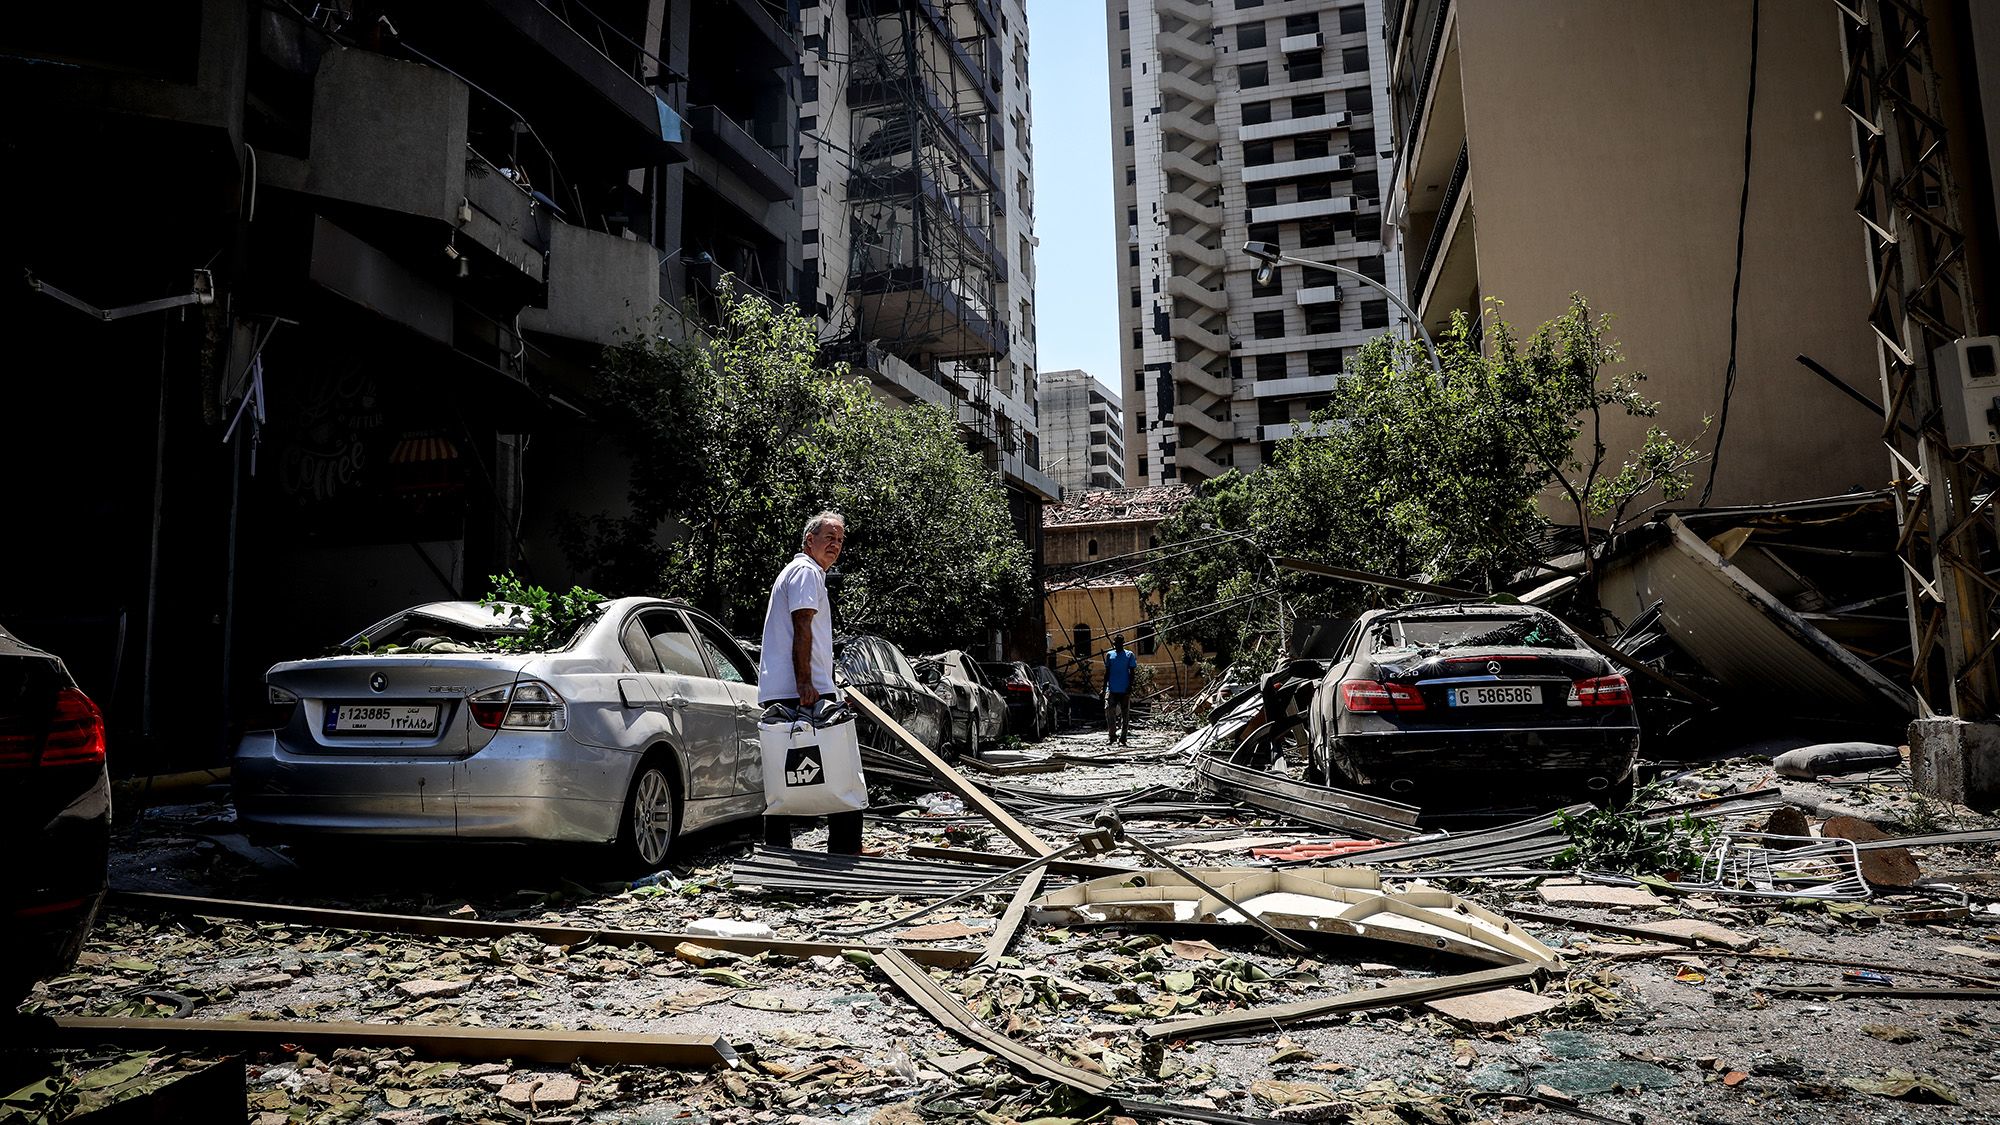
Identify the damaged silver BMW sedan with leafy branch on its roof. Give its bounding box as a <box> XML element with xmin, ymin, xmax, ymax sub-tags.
<box><xmin>232</xmin><ymin>599</ymin><xmax>764</xmax><ymax>869</ymax></box>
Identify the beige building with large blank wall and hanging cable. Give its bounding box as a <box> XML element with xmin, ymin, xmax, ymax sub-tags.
<box><xmin>1382</xmin><ymin>0</ymin><xmax>1888</xmax><ymax>504</ymax></box>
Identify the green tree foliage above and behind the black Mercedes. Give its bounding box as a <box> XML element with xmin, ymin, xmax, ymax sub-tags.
<box><xmin>1146</xmin><ymin>296</ymin><xmax>1702</xmax><ymax>665</ymax></box>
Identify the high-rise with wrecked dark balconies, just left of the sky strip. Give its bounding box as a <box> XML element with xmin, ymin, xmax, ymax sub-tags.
<box><xmin>798</xmin><ymin>0</ymin><xmax>1056</xmax><ymax>504</ymax></box>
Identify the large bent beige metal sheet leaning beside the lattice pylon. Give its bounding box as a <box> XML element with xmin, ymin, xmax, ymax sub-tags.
<box><xmin>1598</xmin><ymin>516</ymin><xmax>1916</xmax><ymax>719</ymax></box>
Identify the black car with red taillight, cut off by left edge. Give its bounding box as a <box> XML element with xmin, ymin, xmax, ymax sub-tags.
<box><xmin>0</xmin><ymin>629</ymin><xmax>112</xmax><ymax>1011</ymax></box>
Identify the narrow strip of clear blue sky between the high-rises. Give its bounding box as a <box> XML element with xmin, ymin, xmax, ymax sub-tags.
<box><xmin>1028</xmin><ymin>0</ymin><xmax>1118</xmax><ymax>400</ymax></box>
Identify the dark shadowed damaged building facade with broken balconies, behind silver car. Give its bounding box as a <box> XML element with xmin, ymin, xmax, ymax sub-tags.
<box><xmin>0</xmin><ymin>0</ymin><xmax>800</xmax><ymax>773</ymax></box>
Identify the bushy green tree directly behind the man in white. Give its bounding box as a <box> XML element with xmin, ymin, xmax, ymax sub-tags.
<box><xmin>568</xmin><ymin>282</ymin><xmax>1028</xmax><ymax>647</ymax></box>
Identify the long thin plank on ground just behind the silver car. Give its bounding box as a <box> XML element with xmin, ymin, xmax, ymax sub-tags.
<box><xmin>104</xmin><ymin>891</ymin><xmax>978</xmax><ymax>969</ymax></box>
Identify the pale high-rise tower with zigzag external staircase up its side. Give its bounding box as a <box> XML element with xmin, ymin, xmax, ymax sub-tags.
<box><xmin>1104</xmin><ymin>0</ymin><xmax>1404</xmax><ymax>484</ymax></box>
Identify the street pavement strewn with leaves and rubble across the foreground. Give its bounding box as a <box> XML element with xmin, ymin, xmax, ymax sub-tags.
<box><xmin>15</xmin><ymin>727</ymin><xmax>2000</xmax><ymax>1125</ymax></box>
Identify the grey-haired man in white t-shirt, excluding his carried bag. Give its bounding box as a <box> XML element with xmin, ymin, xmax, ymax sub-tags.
<box><xmin>756</xmin><ymin>512</ymin><xmax>862</xmax><ymax>855</ymax></box>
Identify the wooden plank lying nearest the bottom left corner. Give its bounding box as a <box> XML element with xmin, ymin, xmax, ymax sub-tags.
<box><xmin>19</xmin><ymin>1015</ymin><xmax>738</xmax><ymax>1067</ymax></box>
